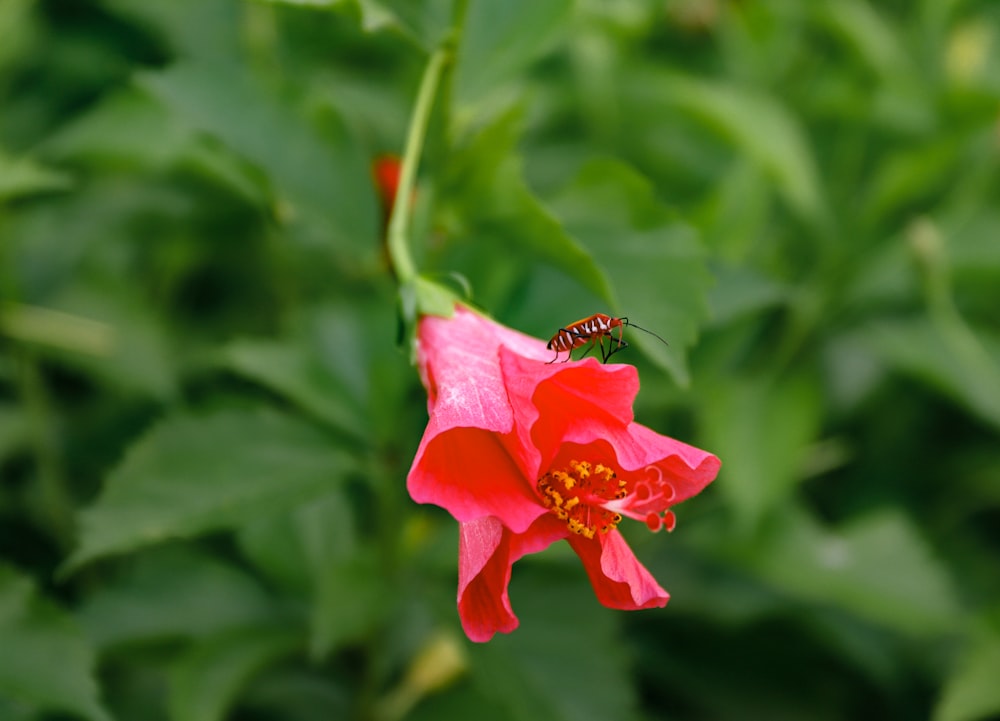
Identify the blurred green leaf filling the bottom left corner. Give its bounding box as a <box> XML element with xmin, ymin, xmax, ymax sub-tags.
<box><xmin>0</xmin><ymin>566</ymin><xmax>110</xmax><ymax>721</ymax></box>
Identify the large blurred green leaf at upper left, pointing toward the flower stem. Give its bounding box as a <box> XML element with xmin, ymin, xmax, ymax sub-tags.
<box><xmin>141</xmin><ymin>62</ymin><xmax>378</xmax><ymax>255</ymax></box>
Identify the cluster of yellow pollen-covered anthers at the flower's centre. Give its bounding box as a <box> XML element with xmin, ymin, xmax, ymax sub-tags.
<box><xmin>538</xmin><ymin>460</ymin><xmax>628</xmax><ymax>538</ymax></box>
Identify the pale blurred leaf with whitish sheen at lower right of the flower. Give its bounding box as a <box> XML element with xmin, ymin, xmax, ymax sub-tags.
<box><xmin>748</xmin><ymin>511</ymin><xmax>962</xmax><ymax>636</ymax></box>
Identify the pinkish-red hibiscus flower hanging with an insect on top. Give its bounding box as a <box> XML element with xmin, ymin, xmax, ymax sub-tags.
<box><xmin>407</xmin><ymin>307</ymin><xmax>720</xmax><ymax>641</ymax></box>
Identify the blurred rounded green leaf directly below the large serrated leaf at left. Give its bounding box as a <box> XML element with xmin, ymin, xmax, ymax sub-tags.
<box><xmin>79</xmin><ymin>547</ymin><xmax>276</xmax><ymax>648</ymax></box>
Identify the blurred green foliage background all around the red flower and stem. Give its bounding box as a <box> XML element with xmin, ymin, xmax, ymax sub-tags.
<box><xmin>0</xmin><ymin>0</ymin><xmax>1000</xmax><ymax>721</ymax></box>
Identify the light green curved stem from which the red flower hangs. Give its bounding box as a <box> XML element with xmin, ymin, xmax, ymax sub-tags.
<box><xmin>388</xmin><ymin>42</ymin><xmax>452</xmax><ymax>285</ymax></box>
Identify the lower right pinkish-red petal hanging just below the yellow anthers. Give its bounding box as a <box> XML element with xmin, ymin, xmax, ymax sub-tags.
<box><xmin>569</xmin><ymin>531</ymin><xmax>670</xmax><ymax>611</ymax></box>
